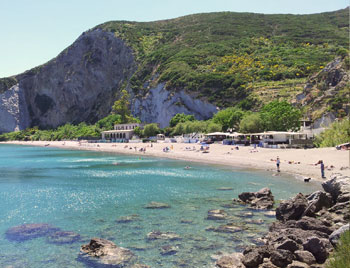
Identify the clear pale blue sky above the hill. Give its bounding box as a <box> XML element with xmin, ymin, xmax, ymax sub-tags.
<box><xmin>0</xmin><ymin>0</ymin><xmax>350</xmax><ymax>78</ymax></box>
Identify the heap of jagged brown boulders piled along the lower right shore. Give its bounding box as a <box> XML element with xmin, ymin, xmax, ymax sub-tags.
<box><xmin>238</xmin><ymin>175</ymin><xmax>350</xmax><ymax>268</ymax></box>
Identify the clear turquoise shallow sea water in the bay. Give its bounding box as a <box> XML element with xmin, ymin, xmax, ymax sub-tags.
<box><xmin>0</xmin><ymin>145</ymin><xmax>319</xmax><ymax>268</ymax></box>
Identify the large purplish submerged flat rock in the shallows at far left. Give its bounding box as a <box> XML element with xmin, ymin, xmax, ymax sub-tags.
<box><xmin>5</xmin><ymin>223</ymin><xmax>59</xmax><ymax>242</ymax></box>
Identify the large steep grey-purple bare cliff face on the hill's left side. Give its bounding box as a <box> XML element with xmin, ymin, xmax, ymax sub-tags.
<box><xmin>0</xmin><ymin>29</ymin><xmax>136</xmax><ymax>131</ymax></box>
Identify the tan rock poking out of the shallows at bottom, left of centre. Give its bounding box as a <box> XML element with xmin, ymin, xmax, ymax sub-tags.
<box><xmin>78</xmin><ymin>238</ymin><xmax>145</xmax><ymax>268</ymax></box>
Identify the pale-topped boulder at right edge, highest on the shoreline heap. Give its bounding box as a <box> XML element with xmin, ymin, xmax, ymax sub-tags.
<box><xmin>322</xmin><ymin>173</ymin><xmax>350</xmax><ymax>201</ymax></box>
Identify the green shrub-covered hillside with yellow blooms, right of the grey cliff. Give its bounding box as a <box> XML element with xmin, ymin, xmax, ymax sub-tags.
<box><xmin>96</xmin><ymin>9</ymin><xmax>349</xmax><ymax>109</ymax></box>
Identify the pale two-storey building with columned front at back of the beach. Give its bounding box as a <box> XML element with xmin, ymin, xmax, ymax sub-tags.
<box><xmin>102</xmin><ymin>123</ymin><xmax>144</xmax><ymax>141</ymax></box>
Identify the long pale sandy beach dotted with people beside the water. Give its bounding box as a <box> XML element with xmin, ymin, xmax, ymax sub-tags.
<box><xmin>0</xmin><ymin>141</ymin><xmax>350</xmax><ymax>181</ymax></box>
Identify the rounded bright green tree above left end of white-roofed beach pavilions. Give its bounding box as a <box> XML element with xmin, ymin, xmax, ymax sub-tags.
<box><xmin>213</xmin><ymin>107</ymin><xmax>244</xmax><ymax>131</ymax></box>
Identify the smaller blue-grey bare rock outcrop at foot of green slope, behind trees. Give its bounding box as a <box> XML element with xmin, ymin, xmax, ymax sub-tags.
<box><xmin>131</xmin><ymin>83</ymin><xmax>217</xmax><ymax>127</ymax></box>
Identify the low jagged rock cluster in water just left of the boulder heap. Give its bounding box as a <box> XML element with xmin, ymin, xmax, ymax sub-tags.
<box><xmin>238</xmin><ymin>188</ymin><xmax>274</xmax><ymax>209</ymax></box>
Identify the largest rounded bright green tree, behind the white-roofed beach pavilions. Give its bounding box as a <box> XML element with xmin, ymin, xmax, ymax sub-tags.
<box><xmin>260</xmin><ymin>100</ymin><xmax>301</xmax><ymax>131</ymax></box>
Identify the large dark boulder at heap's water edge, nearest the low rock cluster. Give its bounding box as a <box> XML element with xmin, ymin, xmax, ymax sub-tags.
<box><xmin>276</xmin><ymin>193</ymin><xmax>308</xmax><ymax>221</ymax></box>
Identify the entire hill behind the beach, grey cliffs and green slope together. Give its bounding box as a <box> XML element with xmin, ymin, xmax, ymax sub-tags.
<box><xmin>0</xmin><ymin>9</ymin><xmax>349</xmax><ymax>132</ymax></box>
